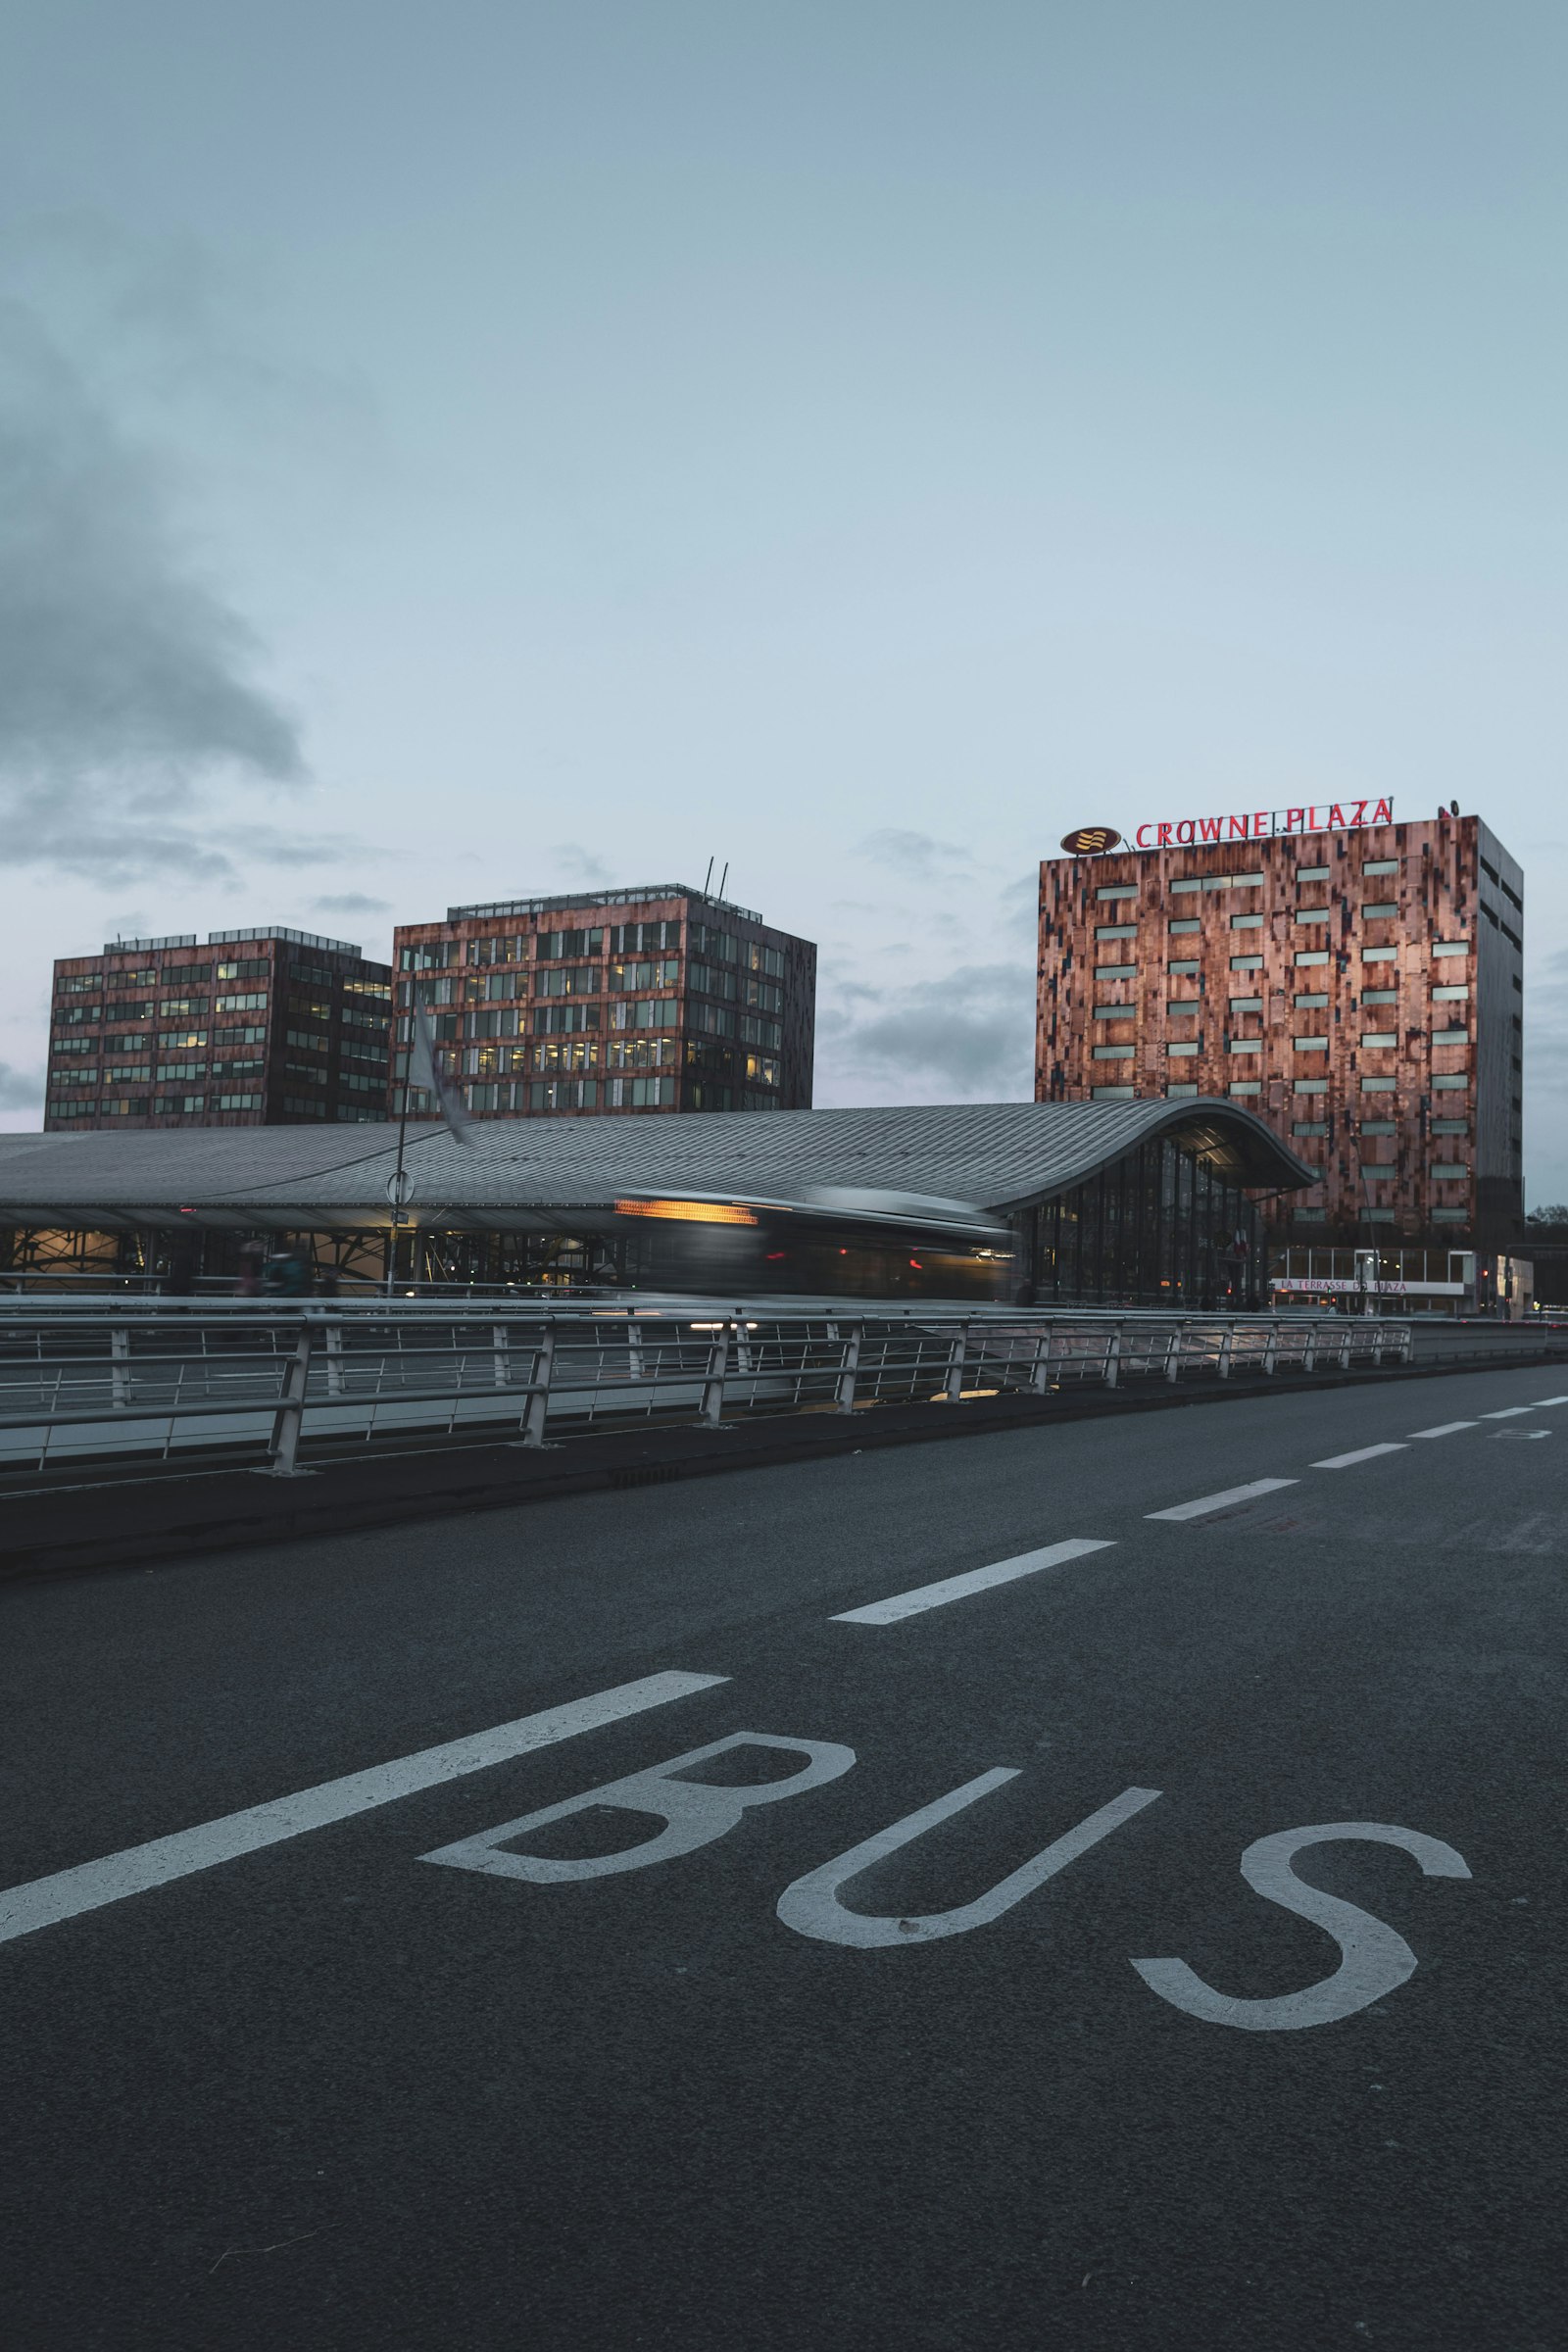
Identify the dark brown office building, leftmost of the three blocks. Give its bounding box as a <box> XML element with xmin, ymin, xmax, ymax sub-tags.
<box><xmin>45</xmin><ymin>927</ymin><xmax>393</xmax><ymax>1129</ymax></box>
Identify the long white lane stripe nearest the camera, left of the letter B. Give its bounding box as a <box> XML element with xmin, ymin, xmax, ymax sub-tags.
<box><xmin>0</xmin><ymin>1675</ymin><xmax>729</xmax><ymax>1942</ymax></box>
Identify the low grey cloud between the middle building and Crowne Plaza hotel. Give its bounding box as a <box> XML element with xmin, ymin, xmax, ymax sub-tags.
<box><xmin>820</xmin><ymin>964</ymin><xmax>1034</xmax><ymax>1103</ymax></box>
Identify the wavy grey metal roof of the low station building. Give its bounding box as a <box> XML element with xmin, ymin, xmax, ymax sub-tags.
<box><xmin>0</xmin><ymin>1099</ymin><xmax>1314</xmax><ymax>1228</ymax></box>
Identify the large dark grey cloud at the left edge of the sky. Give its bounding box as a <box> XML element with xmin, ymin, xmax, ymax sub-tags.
<box><xmin>0</xmin><ymin>267</ymin><xmax>310</xmax><ymax>880</ymax></box>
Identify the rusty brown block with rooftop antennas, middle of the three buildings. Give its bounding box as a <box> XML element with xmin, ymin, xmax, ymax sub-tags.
<box><xmin>388</xmin><ymin>884</ymin><xmax>815</xmax><ymax>1119</ymax></box>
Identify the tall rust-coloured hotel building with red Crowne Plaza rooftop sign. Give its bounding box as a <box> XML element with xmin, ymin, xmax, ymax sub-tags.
<box><xmin>1034</xmin><ymin>802</ymin><xmax>1523</xmax><ymax>1249</ymax></box>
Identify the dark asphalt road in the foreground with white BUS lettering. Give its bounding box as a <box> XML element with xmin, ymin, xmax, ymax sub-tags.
<box><xmin>0</xmin><ymin>1371</ymin><xmax>1568</xmax><ymax>2352</ymax></box>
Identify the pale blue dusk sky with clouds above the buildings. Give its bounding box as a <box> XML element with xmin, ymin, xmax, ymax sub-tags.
<box><xmin>0</xmin><ymin>0</ymin><xmax>1568</xmax><ymax>1204</ymax></box>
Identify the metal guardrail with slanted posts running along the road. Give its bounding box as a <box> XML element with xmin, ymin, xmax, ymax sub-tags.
<box><xmin>0</xmin><ymin>1298</ymin><xmax>1413</xmax><ymax>1477</ymax></box>
